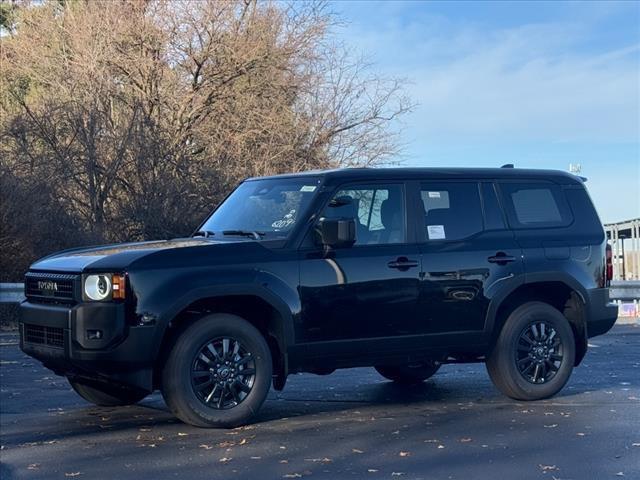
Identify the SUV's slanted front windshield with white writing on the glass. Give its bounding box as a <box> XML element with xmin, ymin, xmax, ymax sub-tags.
<box><xmin>199</xmin><ymin>177</ymin><xmax>320</xmax><ymax>239</ymax></box>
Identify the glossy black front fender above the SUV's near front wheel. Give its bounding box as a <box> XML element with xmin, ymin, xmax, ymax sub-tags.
<box><xmin>130</xmin><ymin>242</ymin><xmax>301</xmax><ymax>356</ymax></box>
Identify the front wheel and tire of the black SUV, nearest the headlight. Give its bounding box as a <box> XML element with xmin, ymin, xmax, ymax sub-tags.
<box><xmin>162</xmin><ymin>313</ymin><xmax>273</xmax><ymax>428</ymax></box>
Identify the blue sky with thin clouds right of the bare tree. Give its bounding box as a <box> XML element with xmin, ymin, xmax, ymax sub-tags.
<box><xmin>330</xmin><ymin>1</ymin><xmax>640</xmax><ymax>222</ymax></box>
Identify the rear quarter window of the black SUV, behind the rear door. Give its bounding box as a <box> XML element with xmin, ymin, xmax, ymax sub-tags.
<box><xmin>500</xmin><ymin>183</ymin><xmax>573</xmax><ymax>228</ymax></box>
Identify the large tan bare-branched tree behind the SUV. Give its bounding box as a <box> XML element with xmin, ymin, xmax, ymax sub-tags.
<box><xmin>0</xmin><ymin>0</ymin><xmax>411</xmax><ymax>280</ymax></box>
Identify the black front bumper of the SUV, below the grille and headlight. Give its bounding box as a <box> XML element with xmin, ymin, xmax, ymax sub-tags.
<box><xmin>20</xmin><ymin>301</ymin><xmax>155</xmax><ymax>391</ymax></box>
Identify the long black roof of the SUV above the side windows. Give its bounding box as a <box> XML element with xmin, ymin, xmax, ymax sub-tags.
<box><xmin>248</xmin><ymin>168</ymin><xmax>583</xmax><ymax>184</ymax></box>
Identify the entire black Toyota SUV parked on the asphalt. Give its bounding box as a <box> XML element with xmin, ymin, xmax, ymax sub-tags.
<box><xmin>20</xmin><ymin>168</ymin><xmax>617</xmax><ymax>427</ymax></box>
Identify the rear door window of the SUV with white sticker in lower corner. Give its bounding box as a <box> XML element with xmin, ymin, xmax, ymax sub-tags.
<box><xmin>420</xmin><ymin>182</ymin><xmax>483</xmax><ymax>241</ymax></box>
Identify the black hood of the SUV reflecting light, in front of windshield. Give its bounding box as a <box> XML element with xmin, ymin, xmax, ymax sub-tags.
<box><xmin>31</xmin><ymin>238</ymin><xmax>214</xmax><ymax>272</ymax></box>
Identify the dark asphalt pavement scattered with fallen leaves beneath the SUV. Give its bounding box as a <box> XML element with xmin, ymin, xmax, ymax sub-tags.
<box><xmin>0</xmin><ymin>325</ymin><xmax>640</xmax><ymax>480</ymax></box>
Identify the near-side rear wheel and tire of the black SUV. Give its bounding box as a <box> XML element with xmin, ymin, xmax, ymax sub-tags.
<box><xmin>486</xmin><ymin>302</ymin><xmax>576</xmax><ymax>400</ymax></box>
